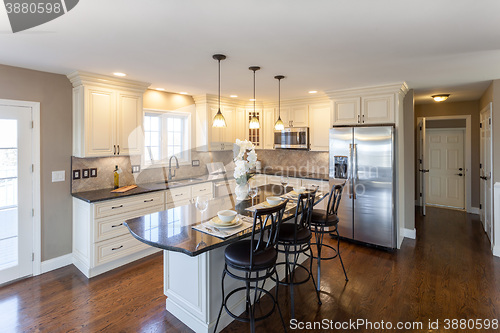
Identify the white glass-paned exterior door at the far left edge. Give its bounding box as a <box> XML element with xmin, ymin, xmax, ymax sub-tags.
<box><xmin>0</xmin><ymin>104</ymin><xmax>33</xmax><ymax>284</ymax></box>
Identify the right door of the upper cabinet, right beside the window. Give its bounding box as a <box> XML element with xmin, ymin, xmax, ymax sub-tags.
<box><xmin>116</xmin><ymin>92</ymin><xmax>143</xmax><ymax>155</ymax></box>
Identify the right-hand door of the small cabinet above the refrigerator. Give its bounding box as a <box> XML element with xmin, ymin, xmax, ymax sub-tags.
<box><xmin>361</xmin><ymin>95</ymin><xmax>394</xmax><ymax>124</ymax></box>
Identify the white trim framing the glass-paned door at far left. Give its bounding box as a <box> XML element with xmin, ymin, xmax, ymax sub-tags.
<box><xmin>0</xmin><ymin>99</ymin><xmax>42</xmax><ymax>275</ymax></box>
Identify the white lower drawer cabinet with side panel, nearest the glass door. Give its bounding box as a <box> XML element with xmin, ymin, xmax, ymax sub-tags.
<box><xmin>73</xmin><ymin>191</ymin><xmax>165</xmax><ymax>278</ymax></box>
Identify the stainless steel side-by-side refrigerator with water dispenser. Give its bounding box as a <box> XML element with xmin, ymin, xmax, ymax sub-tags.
<box><xmin>329</xmin><ymin>126</ymin><xmax>396</xmax><ymax>248</ymax></box>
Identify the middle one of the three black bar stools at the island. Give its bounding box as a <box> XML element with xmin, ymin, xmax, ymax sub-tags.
<box><xmin>276</xmin><ymin>189</ymin><xmax>321</xmax><ymax>319</ymax></box>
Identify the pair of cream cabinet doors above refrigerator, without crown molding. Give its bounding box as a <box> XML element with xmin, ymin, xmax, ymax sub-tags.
<box><xmin>333</xmin><ymin>94</ymin><xmax>395</xmax><ymax>125</ymax></box>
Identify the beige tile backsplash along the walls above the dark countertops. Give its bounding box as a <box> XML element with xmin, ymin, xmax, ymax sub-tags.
<box><xmin>71</xmin><ymin>149</ymin><xmax>328</xmax><ymax>193</ymax></box>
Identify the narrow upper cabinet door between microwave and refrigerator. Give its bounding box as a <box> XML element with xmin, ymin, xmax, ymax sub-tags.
<box><xmin>309</xmin><ymin>105</ymin><xmax>331</xmax><ymax>151</ymax></box>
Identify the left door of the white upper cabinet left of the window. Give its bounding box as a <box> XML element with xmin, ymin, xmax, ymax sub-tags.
<box><xmin>85</xmin><ymin>87</ymin><xmax>116</xmax><ymax>157</ymax></box>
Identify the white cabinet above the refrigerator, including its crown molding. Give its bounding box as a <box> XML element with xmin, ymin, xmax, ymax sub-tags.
<box><xmin>328</xmin><ymin>84</ymin><xmax>408</xmax><ymax>125</ymax></box>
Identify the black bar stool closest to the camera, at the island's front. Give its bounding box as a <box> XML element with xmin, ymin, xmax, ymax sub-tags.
<box><xmin>214</xmin><ymin>200</ymin><xmax>288</xmax><ymax>333</ymax></box>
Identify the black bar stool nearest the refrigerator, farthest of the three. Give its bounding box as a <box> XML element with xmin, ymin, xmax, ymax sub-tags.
<box><xmin>311</xmin><ymin>185</ymin><xmax>349</xmax><ymax>291</ymax></box>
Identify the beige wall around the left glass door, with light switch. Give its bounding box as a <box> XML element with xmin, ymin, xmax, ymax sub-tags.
<box><xmin>0</xmin><ymin>65</ymin><xmax>72</xmax><ymax>261</ymax></box>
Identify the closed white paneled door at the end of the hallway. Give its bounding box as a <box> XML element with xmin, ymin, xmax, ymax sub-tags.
<box><xmin>425</xmin><ymin>128</ymin><xmax>465</xmax><ymax>209</ymax></box>
